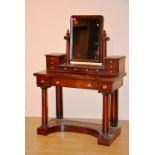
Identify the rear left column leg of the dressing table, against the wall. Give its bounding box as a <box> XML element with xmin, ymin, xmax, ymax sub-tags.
<box><xmin>56</xmin><ymin>86</ymin><xmax>63</xmax><ymax>119</ymax></box>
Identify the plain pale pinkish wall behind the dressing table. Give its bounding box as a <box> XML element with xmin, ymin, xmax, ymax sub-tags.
<box><xmin>25</xmin><ymin>0</ymin><xmax>129</xmax><ymax>120</ymax></box>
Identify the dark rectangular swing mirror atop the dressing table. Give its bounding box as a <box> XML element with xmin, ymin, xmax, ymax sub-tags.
<box><xmin>70</xmin><ymin>16</ymin><xmax>102</xmax><ymax>62</ymax></box>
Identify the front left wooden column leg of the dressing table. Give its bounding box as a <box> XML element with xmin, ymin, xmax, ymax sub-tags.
<box><xmin>41</xmin><ymin>87</ymin><xmax>48</xmax><ymax>128</ymax></box>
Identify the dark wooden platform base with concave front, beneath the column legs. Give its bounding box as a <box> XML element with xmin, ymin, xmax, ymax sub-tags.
<box><xmin>37</xmin><ymin>119</ymin><xmax>121</xmax><ymax>146</ymax></box>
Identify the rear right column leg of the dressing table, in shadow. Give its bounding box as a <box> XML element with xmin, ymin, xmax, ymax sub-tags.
<box><xmin>110</xmin><ymin>90</ymin><xmax>118</xmax><ymax>127</ymax></box>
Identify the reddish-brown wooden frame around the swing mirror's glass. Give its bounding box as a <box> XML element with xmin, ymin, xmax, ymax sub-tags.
<box><xmin>69</xmin><ymin>15</ymin><xmax>104</xmax><ymax>63</ymax></box>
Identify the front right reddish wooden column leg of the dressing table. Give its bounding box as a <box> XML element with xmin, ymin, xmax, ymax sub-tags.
<box><xmin>102</xmin><ymin>93</ymin><xmax>109</xmax><ymax>134</ymax></box>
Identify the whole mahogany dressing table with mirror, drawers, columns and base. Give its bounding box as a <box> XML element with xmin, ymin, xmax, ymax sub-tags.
<box><xmin>34</xmin><ymin>15</ymin><xmax>126</xmax><ymax>146</ymax></box>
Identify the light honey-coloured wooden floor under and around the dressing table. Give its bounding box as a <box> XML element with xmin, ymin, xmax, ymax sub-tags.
<box><xmin>25</xmin><ymin>117</ymin><xmax>129</xmax><ymax>155</ymax></box>
